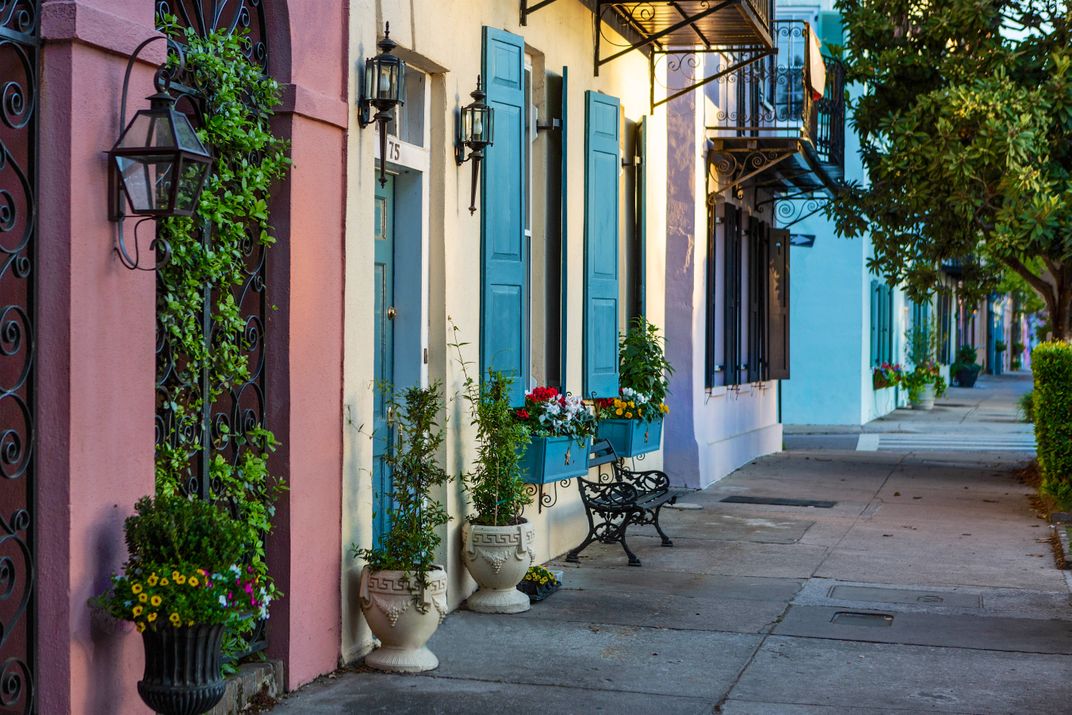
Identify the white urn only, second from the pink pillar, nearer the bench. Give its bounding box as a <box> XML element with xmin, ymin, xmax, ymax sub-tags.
<box><xmin>462</xmin><ymin>521</ymin><xmax>536</xmax><ymax>613</ymax></box>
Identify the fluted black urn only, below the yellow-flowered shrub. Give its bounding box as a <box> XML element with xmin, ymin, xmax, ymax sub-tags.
<box><xmin>137</xmin><ymin>624</ymin><xmax>227</xmax><ymax>715</ymax></box>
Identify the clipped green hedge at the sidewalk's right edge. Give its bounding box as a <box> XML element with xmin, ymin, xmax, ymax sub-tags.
<box><xmin>1031</xmin><ymin>342</ymin><xmax>1072</xmax><ymax>508</ymax></box>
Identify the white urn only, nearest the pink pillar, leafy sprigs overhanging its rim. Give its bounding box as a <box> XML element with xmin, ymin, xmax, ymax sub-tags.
<box><xmin>358</xmin><ymin>567</ymin><xmax>447</xmax><ymax>673</ymax></box>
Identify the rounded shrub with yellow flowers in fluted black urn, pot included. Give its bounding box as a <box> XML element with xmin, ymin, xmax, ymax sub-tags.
<box><xmin>95</xmin><ymin>495</ymin><xmax>278</xmax><ymax>715</ymax></box>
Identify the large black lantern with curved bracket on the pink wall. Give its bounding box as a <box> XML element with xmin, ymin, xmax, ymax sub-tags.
<box><xmin>108</xmin><ymin>35</ymin><xmax>212</xmax><ymax>270</ymax></box>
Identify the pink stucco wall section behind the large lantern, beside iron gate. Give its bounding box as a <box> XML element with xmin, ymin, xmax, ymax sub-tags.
<box><xmin>35</xmin><ymin>0</ymin><xmax>163</xmax><ymax>713</ymax></box>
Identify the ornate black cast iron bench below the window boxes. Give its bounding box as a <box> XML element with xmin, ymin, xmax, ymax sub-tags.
<box><xmin>566</xmin><ymin>440</ymin><xmax>688</xmax><ymax>566</ymax></box>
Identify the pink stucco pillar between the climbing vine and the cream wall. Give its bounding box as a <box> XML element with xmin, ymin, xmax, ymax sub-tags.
<box><xmin>268</xmin><ymin>0</ymin><xmax>347</xmax><ymax>688</ymax></box>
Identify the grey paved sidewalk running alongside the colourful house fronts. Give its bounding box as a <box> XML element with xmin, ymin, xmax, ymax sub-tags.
<box><xmin>272</xmin><ymin>374</ymin><xmax>1072</xmax><ymax>715</ymax></box>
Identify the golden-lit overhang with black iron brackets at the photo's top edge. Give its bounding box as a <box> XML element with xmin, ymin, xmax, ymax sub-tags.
<box><xmin>520</xmin><ymin>0</ymin><xmax>774</xmax><ymax>110</ymax></box>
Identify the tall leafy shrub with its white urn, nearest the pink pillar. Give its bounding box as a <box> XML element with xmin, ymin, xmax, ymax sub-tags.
<box><xmin>352</xmin><ymin>383</ymin><xmax>450</xmax><ymax>672</ymax></box>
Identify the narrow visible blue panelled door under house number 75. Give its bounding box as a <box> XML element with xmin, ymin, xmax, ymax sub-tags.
<box><xmin>372</xmin><ymin>177</ymin><xmax>394</xmax><ymax>546</ymax></box>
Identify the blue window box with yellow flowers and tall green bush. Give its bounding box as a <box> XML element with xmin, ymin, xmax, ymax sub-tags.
<box><xmin>595</xmin><ymin>315</ymin><xmax>673</xmax><ymax>457</ymax></box>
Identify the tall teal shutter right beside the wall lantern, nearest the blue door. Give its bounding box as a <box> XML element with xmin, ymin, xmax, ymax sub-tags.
<box><xmin>480</xmin><ymin>27</ymin><xmax>528</xmax><ymax>405</ymax></box>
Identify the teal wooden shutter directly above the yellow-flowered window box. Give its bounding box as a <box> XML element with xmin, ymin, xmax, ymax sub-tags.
<box><xmin>584</xmin><ymin>90</ymin><xmax>622</xmax><ymax>397</ymax></box>
